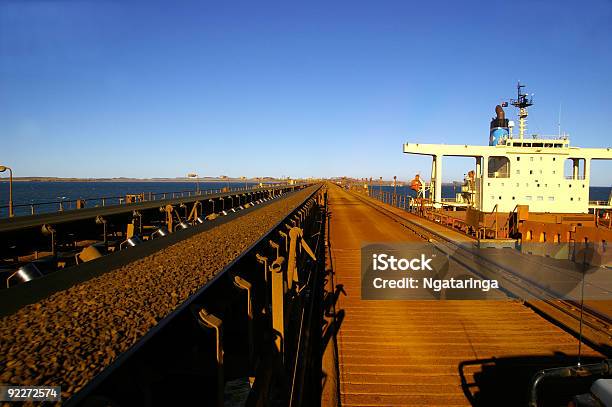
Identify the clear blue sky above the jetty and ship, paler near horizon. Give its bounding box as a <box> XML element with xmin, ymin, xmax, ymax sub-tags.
<box><xmin>0</xmin><ymin>0</ymin><xmax>612</xmax><ymax>185</ymax></box>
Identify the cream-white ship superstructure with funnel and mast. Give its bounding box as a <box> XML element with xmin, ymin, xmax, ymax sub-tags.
<box><xmin>404</xmin><ymin>83</ymin><xmax>612</xmax><ymax>213</ymax></box>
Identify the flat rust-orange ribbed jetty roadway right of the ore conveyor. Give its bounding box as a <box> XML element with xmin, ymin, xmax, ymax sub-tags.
<box><xmin>329</xmin><ymin>187</ymin><xmax>602</xmax><ymax>406</ymax></box>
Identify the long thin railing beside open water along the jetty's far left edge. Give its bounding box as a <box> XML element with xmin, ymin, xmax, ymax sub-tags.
<box><xmin>0</xmin><ymin>184</ymin><xmax>281</xmax><ymax>218</ymax></box>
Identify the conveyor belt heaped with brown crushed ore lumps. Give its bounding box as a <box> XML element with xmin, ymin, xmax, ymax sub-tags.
<box><xmin>0</xmin><ymin>187</ymin><xmax>318</xmax><ymax>399</ymax></box>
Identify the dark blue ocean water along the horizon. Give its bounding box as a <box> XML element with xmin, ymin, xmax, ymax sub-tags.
<box><xmin>0</xmin><ymin>181</ymin><xmax>611</xmax><ymax>217</ymax></box>
